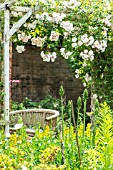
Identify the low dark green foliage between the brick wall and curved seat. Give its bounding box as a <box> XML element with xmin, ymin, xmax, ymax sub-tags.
<box><xmin>11</xmin><ymin>91</ymin><xmax>70</xmax><ymax>119</ymax></box>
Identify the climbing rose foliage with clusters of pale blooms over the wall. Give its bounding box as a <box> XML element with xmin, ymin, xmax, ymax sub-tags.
<box><xmin>0</xmin><ymin>0</ymin><xmax>113</xmax><ymax>107</ymax></box>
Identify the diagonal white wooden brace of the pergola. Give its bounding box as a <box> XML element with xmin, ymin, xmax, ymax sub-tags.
<box><xmin>6</xmin><ymin>10</ymin><xmax>32</xmax><ymax>40</ymax></box>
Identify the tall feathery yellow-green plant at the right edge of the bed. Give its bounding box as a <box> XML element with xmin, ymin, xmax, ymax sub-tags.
<box><xmin>96</xmin><ymin>103</ymin><xmax>113</xmax><ymax>170</ymax></box>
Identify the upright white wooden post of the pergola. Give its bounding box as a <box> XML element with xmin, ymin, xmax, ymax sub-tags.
<box><xmin>4</xmin><ymin>9</ymin><xmax>10</xmax><ymax>137</ymax></box>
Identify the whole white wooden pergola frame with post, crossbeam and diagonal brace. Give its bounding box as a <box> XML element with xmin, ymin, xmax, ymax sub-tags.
<box><xmin>0</xmin><ymin>0</ymin><xmax>38</xmax><ymax>137</ymax></box>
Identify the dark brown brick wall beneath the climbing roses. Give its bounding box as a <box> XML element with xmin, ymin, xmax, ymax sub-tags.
<box><xmin>12</xmin><ymin>45</ymin><xmax>83</xmax><ymax>102</ymax></box>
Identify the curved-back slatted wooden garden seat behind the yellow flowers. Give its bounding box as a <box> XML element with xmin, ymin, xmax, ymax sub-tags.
<box><xmin>9</xmin><ymin>109</ymin><xmax>59</xmax><ymax>134</ymax></box>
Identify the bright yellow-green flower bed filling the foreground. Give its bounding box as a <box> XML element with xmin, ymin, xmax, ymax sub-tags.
<box><xmin>0</xmin><ymin>90</ymin><xmax>113</xmax><ymax>170</ymax></box>
